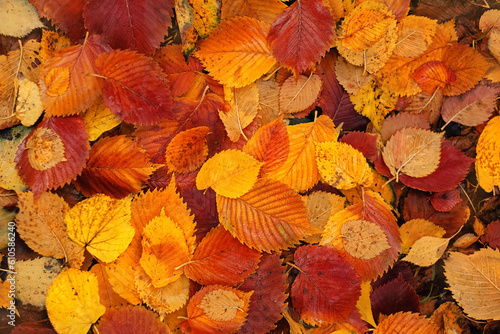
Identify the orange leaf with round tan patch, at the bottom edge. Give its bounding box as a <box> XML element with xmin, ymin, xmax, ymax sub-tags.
<box><xmin>181</xmin><ymin>285</ymin><xmax>252</xmax><ymax>333</ymax></box>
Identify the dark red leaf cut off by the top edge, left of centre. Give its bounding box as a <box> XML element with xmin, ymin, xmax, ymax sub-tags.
<box><xmin>83</xmin><ymin>0</ymin><xmax>174</xmax><ymax>54</ymax></box>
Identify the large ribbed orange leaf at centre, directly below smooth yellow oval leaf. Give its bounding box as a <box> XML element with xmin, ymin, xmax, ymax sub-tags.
<box><xmin>217</xmin><ymin>179</ymin><xmax>314</xmax><ymax>252</ymax></box>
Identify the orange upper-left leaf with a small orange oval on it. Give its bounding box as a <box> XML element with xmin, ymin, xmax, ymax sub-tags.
<box><xmin>40</xmin><ymin>35</ymin><xmax>109</xmax><ymax>116</ymax></box>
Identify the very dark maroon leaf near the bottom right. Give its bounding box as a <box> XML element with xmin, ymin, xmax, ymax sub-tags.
<box><xmin>370</xmin><ymin>274</ymin><xmax>420</xmax><ymax>322</ymax></box>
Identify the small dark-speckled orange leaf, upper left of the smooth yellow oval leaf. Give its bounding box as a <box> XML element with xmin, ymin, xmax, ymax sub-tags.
<box><xmin>165</xmin><ymin>126</ymin><xmax>210</xmax><ymax>173</ymax></box>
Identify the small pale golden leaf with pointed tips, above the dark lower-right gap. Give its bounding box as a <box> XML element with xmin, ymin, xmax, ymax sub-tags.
<box><xmin>403</xmin><ymin>237</ymin><xmax>451</xmax><ymax>267</ymax></box>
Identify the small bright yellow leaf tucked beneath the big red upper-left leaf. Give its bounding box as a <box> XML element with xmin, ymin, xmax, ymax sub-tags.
<box><xmin>83</xmin><ymin>99</ymin><xmax>122</xmax><ymax>141</ymax></box>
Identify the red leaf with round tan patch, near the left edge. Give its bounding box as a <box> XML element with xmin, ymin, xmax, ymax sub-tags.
<box><xmin>15</xmin><ymin>116</ymin><xmax>90</xmax><ymax>197</ymax></box>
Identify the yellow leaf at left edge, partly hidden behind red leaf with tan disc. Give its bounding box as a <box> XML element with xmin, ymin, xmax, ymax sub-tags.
<box><xmin>0</xmin><ymin>124</ymin><xmax>31</xmax><ymax>191</ymax></box>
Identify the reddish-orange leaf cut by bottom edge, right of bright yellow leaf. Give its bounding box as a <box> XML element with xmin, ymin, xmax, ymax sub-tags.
<box><xmin>97</xmin><ymin>306</ymin><xmax>170</xmax><ymax>334</ymax></box>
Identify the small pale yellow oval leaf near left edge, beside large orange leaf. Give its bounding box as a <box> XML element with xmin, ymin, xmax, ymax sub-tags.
<box><xmin>16</xmin><ymin>78</ymin><xmax>43</xmax><ymax>126</ymax></box>
